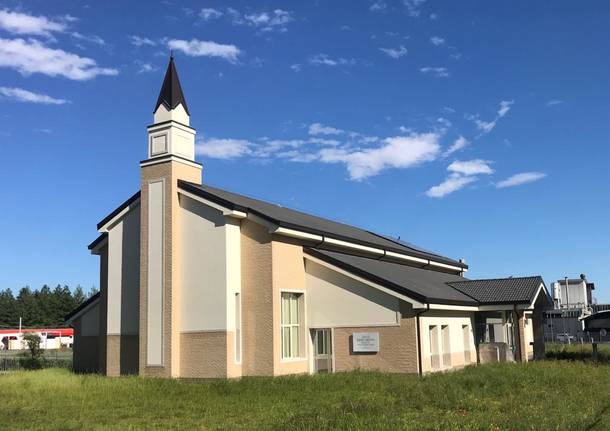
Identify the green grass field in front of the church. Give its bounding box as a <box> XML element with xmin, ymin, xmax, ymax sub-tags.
<box><xmin>0</xmin><ymin>360</ymin><xmax>610</xmax><ymax>430</ymax></box>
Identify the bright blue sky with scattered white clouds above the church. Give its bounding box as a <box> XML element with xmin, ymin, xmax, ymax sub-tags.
<box><xmin>0</xmin><ymin>0</ymin><xmax>610</xmax><ymax>301</ymax></box>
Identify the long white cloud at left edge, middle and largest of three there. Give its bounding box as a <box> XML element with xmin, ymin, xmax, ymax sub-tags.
<box><xmin>0</xmin><ymin>39</ymin><xmax>119</xmax><ymax>81</ymax></box>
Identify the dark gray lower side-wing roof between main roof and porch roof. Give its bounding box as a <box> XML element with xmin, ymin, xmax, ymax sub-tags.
<box><xmin>305</xmin><ymin>248</ymin><xmax>479</xmax><ymax>306</ymax></box>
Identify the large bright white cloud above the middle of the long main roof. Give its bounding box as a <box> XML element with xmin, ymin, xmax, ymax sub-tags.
<box><xmin>319</xmin><ymin>133</ymin><xmax>440</xmax><ymax>181</ymax></box>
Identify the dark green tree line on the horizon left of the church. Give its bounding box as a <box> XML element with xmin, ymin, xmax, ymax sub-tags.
<box><xmin>0</xmin><ymin>284</ymin><xmax>97</xmax><ymax>329</ymax></box>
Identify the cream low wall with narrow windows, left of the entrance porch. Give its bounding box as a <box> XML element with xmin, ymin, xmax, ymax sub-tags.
<box><xmin>420</xmin><ymin>310</ymin><xmax>477</xmax><ymax>373</ymax></box>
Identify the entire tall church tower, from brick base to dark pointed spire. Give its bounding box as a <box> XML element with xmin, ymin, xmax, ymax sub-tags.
<box><xmin>139</xmin><ymin>58</ymin><xmax>202</xmax><ymax>377</ymax></box>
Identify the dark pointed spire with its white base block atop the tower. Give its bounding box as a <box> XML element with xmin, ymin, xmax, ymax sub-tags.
<box><xmin>148</xmin><ymin>56</ymin><xmax>196</xmax><ymax>162</ymax></box>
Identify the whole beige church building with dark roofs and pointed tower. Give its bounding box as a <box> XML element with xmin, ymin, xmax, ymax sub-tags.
<box><xmin>66</xmin><ymin>58</ymin><xmax>549</xmax><ymax>378</ymax></box>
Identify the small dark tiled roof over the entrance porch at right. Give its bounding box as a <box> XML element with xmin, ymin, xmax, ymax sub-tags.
<box><xmin>449</xmin><ymin>276</ymin><xmax>546</xmax><ymax>304</ymax></box>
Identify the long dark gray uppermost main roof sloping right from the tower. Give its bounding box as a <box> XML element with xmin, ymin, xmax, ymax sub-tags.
<box><xmin>178</xmin><ymin>180</ymin><xmax>468</xmax><ymax>268</ymax></box>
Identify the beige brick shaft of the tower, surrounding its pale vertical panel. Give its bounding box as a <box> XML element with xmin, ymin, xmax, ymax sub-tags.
<box><xmin>139</xmin><ymin>161</ymin><xmax>201</xmax><ymax>377</ymax></box>
